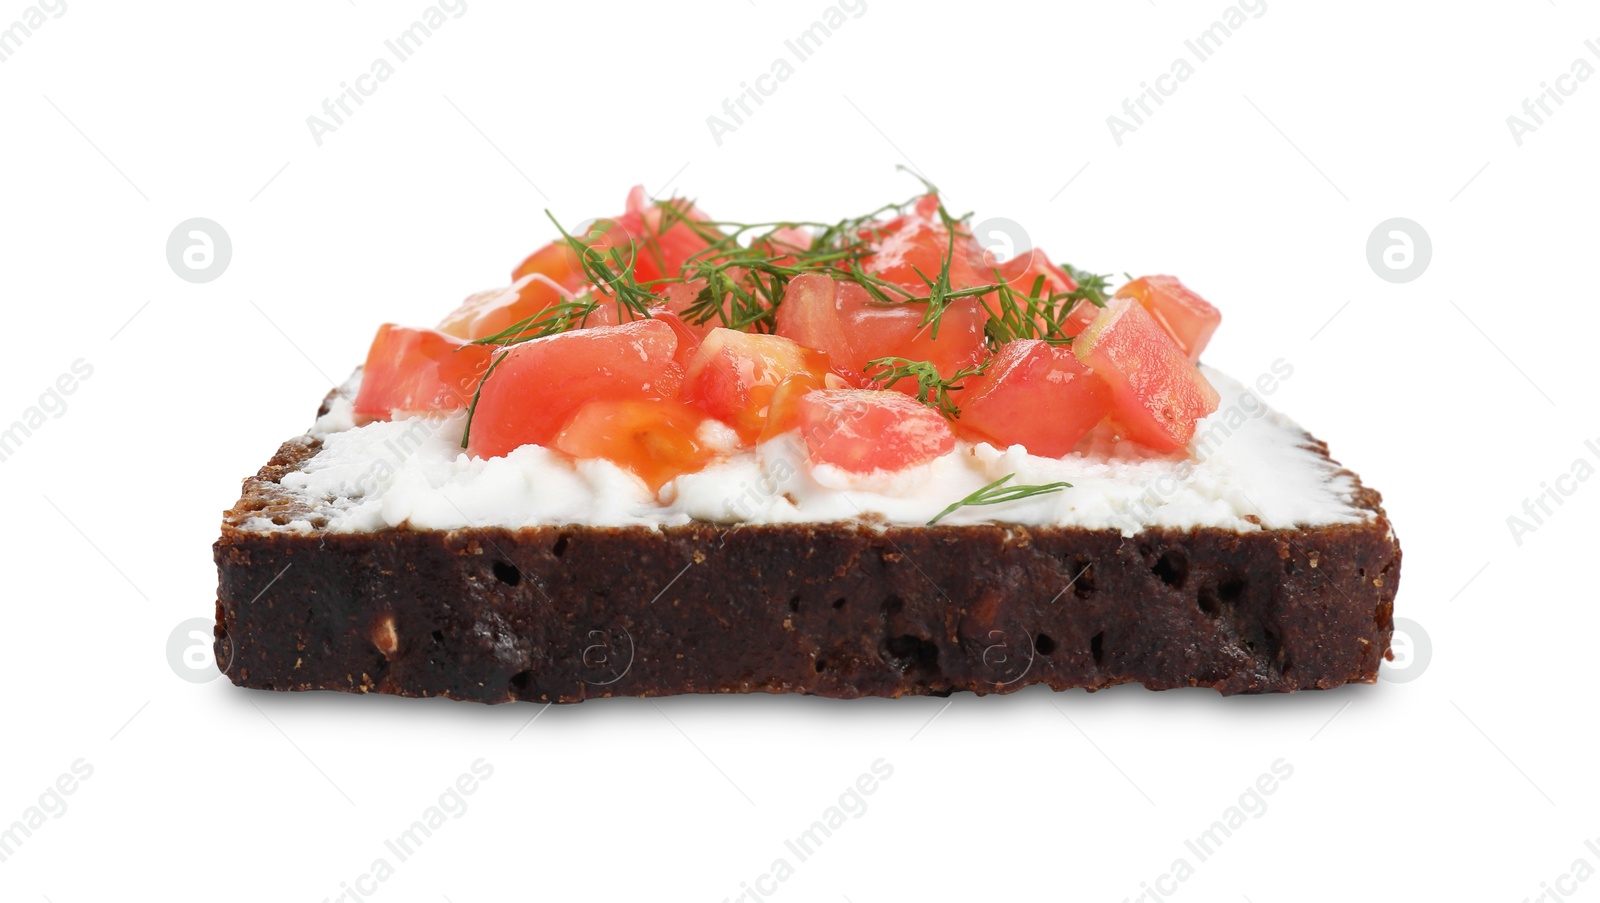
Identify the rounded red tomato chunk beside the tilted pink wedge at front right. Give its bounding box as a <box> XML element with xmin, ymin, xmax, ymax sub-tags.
<box><xmin>952</xmin><ymin>339</ymin><xmax>1110</xmax><ymax>458</ymax></box>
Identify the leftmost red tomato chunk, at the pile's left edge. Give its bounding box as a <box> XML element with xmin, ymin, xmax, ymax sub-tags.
<box><xmin>355</xmin><ymin>323</ymin><xmax>494</xmax><ymax>419</ymax></box>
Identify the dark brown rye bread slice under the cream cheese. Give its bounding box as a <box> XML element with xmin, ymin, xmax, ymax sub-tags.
<box><xmin>214</xmin><ymin>385</ymin><xmax>1400</xmax><ymax>703</ymax></box>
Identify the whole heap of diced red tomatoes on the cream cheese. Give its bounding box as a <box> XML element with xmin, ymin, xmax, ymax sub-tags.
<box><xmin>377</xmin><ymin>187</ymin><xmax>1221</xmax><ymax>488</ymax></box>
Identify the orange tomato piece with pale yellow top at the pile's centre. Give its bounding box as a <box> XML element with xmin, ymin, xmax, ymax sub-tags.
<box><xmin>683</xmin><ymin>328</ymin><xmax>827</xmax><ymax>440</ymax></box>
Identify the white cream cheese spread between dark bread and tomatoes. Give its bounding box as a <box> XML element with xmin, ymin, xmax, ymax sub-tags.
<box><xmin>245</xmin><ymin>370</ymin><xmax>1371</xmax><ymax>536</ymax></box>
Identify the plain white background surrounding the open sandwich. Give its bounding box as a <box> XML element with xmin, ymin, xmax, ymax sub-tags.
<box><xmin>0</xmin><ymin>0</ymin><xmax>1600</xmax><ymax>903</ymax></box>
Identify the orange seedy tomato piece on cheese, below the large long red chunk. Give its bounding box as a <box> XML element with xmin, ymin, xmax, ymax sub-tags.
<box><xmin>556</xmin><ymin>398</ymin><xmax>717</xmax><ymax>492</ymax></box>
